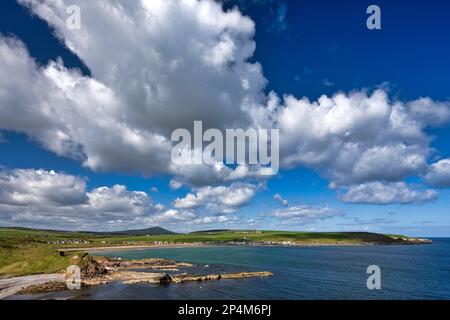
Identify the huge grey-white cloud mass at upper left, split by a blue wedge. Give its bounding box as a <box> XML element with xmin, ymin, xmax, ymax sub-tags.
<box><xmin>0</xmin><ymin>0</ymin><xmax>265</xmax><ymax>184</ymax></box>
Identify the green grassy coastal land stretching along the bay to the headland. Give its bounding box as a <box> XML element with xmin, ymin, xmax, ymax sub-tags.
<box><xmin>0</xmin><ymin>228</ymin><xmax>414</xmax><ymax>277</ymax></box>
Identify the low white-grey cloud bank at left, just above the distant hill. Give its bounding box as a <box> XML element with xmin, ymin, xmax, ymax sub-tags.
<box><xmin>0</xmin><ymin>169</ymin><xmax>182</xmax><ymax>230</ymax></box>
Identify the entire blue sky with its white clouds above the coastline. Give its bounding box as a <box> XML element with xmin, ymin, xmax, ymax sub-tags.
<box><xmin>0</xmin><ymin>0</ymin><xmax>450</xmax><ymax>236</ymax></box>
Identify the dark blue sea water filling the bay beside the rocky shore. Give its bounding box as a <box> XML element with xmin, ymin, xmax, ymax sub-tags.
<box><xmin>8</xmin><ymin>238</ymin><xmax>450</xmax><ymax>300</ymax></box>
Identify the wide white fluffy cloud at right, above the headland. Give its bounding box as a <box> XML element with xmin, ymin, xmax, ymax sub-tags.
<box><xmin>258</xmin><ymin>89</ymin><xmax>450</xmax><ymax>185</ymax></box>
